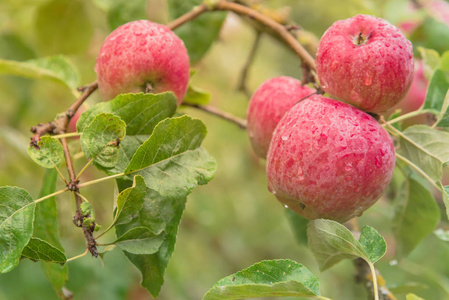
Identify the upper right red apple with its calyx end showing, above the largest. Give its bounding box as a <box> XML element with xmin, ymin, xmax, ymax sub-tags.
<box><xmin>315</xmin><ymin>15</ymin><xmax>413</xmax><ymax>114</ymax></box>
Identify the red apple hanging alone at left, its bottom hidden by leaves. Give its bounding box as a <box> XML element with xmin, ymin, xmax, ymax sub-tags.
<box><xmin>95</xmin><ymin>20</ymin><xmax>190</xmax><ymax>105</ymax></box>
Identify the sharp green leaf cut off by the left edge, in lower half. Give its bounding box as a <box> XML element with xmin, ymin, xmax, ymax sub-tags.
<box><xmin>0</xmin><ymin>186</ymin><xmax>35</xmax><ymax>273</ymax></box>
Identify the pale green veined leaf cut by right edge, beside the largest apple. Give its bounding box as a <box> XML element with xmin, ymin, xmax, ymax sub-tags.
<box><xmin>400</xmin><ymin>125</ymin><xmax>449</xmax><ymax>181</ymax></box>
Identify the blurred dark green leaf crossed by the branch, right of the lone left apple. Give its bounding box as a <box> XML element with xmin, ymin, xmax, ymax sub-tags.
<box><xmin>168</xmin><ymin>0</ymin><xmax>226</xmax><ymax>65</ymax></box>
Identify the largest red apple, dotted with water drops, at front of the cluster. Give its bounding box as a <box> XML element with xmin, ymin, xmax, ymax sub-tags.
<box><xmin>266</xmin><ymin>95</ymin><xmax>395</xmax><ymax>222</ymax></box>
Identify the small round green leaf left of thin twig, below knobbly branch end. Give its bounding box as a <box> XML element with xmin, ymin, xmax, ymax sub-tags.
<box><xmin>27</xmin><ymin>136</ymin><xmax>64</xmax><ymax>169</ymax></box>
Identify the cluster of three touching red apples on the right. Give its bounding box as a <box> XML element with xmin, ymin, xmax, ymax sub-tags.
<box><xmin>248</xmin><ymin>15</ymin><xmax>414</xmax><ymax>222</ymax></box>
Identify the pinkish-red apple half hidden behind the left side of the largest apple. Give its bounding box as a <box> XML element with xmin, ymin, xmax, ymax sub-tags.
<box><xmin>247</xmin><ymin>76</ymin><xmax>316</xmax><ymax>159</ymax></box>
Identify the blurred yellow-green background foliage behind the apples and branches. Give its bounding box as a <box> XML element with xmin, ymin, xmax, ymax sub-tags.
<box><xmin>0</xmin><ymin>0</ymin><xmax>449</xmax><ymax>300</ymax></box>
